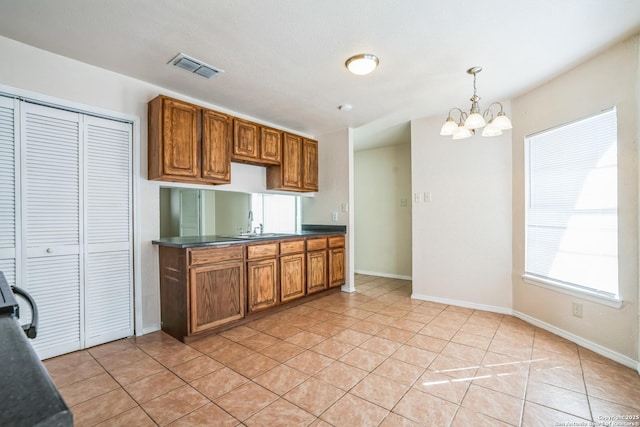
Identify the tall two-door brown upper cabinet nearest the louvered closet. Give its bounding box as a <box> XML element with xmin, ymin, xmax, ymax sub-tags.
<box><xmin>148</xmin><ymin>95</ymin><xmax>231</xmax><ymax>184</ymax></box>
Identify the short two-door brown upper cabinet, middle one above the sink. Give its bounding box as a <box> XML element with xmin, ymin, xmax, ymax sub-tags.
<box><xmin>231</xmin><ymin>119</ymin><xmax>282</xmax><ymax>166</ymax></box>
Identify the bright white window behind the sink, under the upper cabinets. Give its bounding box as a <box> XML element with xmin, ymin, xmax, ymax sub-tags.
<box><xmin>251</xmin><ymin>194</ymin><xmax>300</xmax><ymax>233</ymax></box>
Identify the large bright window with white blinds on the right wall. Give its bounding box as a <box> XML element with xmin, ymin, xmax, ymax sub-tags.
<box><xmin>523</xmin><ymin>108</ymin><xmax>618</xmax><ymax>301</ymax></box>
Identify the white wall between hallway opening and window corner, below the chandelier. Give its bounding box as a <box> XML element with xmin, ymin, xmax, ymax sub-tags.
<box><xmin>411</xmin><ymin>115</ymin><xmax>511</xmax><ymax>312</ymax></box>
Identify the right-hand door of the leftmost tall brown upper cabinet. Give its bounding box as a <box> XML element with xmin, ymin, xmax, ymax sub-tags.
<box><xmin>202</xmin><ymin>110</ymin><xmax>231</xmax><ymax>184</ymax></box>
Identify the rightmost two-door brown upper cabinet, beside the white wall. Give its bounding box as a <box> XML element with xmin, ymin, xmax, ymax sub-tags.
<box><xmin>267</xmin><ymin>133</ymin><xmax>318</xmax><ymax>192</ymax></box>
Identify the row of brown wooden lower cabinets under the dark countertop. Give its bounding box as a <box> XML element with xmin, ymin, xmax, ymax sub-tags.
<box><xmin>159</xmin><ymin>236</ymin><xmax>345</xmax><ymax>340</ymax></box>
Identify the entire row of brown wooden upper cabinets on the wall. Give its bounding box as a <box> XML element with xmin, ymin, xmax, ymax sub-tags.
<box><xmin>148</xmin><ymin>95</ymin><xmax>318</xmax><ymax>192</ymax></box>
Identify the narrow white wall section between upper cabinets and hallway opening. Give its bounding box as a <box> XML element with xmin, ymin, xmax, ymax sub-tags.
<box><xmin>302</xmin><ymin>129</ymin><xmax>354</xmax><ymax>291</ymax></box>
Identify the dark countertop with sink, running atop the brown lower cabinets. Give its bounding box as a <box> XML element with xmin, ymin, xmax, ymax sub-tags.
<box><xmin>152</xmin><ymin>225</ymin><xmax>347</xmax><ymax>249</ymax></box>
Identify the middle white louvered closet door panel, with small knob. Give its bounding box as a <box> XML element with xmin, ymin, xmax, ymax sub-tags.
<box><xmin>21</xmin><ymin>103</ymin><xmax>83</xmax><ymax>359</ymax></box>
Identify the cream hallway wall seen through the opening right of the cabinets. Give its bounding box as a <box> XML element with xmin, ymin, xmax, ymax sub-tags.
<box><xmin>354</xmin><ymin>143</ymin><xmax>411</xmax><ymax>279</ymax></box>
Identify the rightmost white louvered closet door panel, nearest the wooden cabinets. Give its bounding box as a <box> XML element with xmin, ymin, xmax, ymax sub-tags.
<box><xmin>85</xmin><ymin>117</ymin><xmax>133</xmax><ymax>347</ymax></box>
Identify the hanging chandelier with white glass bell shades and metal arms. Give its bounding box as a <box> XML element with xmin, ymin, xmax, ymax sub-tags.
<box><xmin>440</xmin><ymin>67</ymin><xmax>511</xmax><ymax>139</ymax></box>
